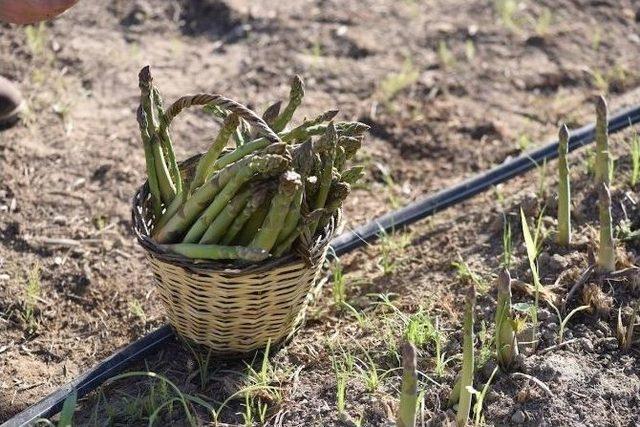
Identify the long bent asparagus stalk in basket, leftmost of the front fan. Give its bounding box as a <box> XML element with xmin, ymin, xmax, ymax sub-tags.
<box><xmin>154</xmin><ymin>155</ymin><xmax>288</xmax><ymax>243</ymax></box>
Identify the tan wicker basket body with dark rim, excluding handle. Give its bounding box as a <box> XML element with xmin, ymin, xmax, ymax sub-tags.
<box><xmin>132</xmin><ymin>156</ymin><xmax>339</xmax><ymax>356</ymax></box>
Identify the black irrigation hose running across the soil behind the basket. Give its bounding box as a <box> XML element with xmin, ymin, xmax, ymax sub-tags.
<box><xmin>7</xmin><ymin>105</ymin><xmax>640</xmax><ymax>427</ymax></box>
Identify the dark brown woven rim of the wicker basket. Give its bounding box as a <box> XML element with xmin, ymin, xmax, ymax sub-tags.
<box><xmin>131</xmin><ymin>153</ymin><xmax>341</xmax><ymax>275</ymax></box>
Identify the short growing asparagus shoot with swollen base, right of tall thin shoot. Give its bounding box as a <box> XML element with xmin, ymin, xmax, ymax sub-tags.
<box><xmin>495</xmin><ymin>270</ymin><xmax>518</xmax><ymax>372</ymax></box>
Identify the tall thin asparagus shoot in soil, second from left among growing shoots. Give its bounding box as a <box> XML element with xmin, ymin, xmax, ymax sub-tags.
<box><xmin>456</xmin><ymin>286</ymin><xmax>476</xmax><ymax>427</ymax></box>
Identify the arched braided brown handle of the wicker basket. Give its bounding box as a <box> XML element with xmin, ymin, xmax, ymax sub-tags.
<box><xmin>162</xmin><ymin>93</ymin><xmax>281</xmax><ymax>142</ymax></box>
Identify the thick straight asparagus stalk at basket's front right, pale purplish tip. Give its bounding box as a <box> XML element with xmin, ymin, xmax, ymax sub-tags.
<box><xmin>249</xmin><ymin>171</ymin><xmax>302</xmax><ymax>251</ymax></box>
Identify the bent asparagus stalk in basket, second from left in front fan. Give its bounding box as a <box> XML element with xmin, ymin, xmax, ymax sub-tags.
<box><xmin>182</xmin><ymin>155</ymin><xmax>288</xmax><ymax>244</ymax></box>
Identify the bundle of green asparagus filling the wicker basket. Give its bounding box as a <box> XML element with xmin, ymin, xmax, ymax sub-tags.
<box><xmin>138</xmin><ymin>67</ymin><xmax>368</xmax><ymax>262</ymax></box>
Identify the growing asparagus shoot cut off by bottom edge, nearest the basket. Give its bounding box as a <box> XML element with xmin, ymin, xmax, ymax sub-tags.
<box><xmin>396</xmin><ymin>342</ymin><xmax>418</xmax><ymax>427</ymax></box>
